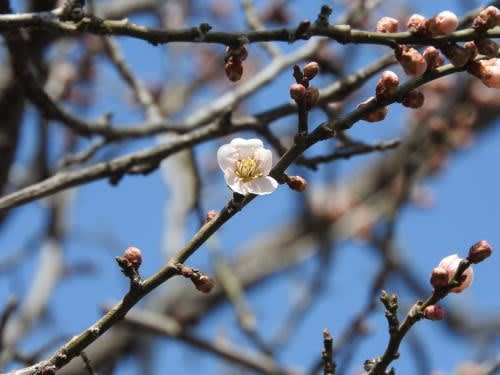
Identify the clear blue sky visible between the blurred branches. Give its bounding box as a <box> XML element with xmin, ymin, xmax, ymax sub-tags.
<box><xmin>0</xmin><ymin>0</ymin><xmax>500</xmax><ymax>374</ymax></box>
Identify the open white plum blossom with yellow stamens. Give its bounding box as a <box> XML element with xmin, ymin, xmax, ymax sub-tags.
<box><xmin>217</xmin><ymin>138</ymin><xmax>278</xmax><ymax>195</ymax></box>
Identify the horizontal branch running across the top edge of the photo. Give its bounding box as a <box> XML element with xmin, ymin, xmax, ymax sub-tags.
<box><xmin>0</xmin><ymin>8</ymin><xmax>500</xmax><ymax>48</ymax></box>
